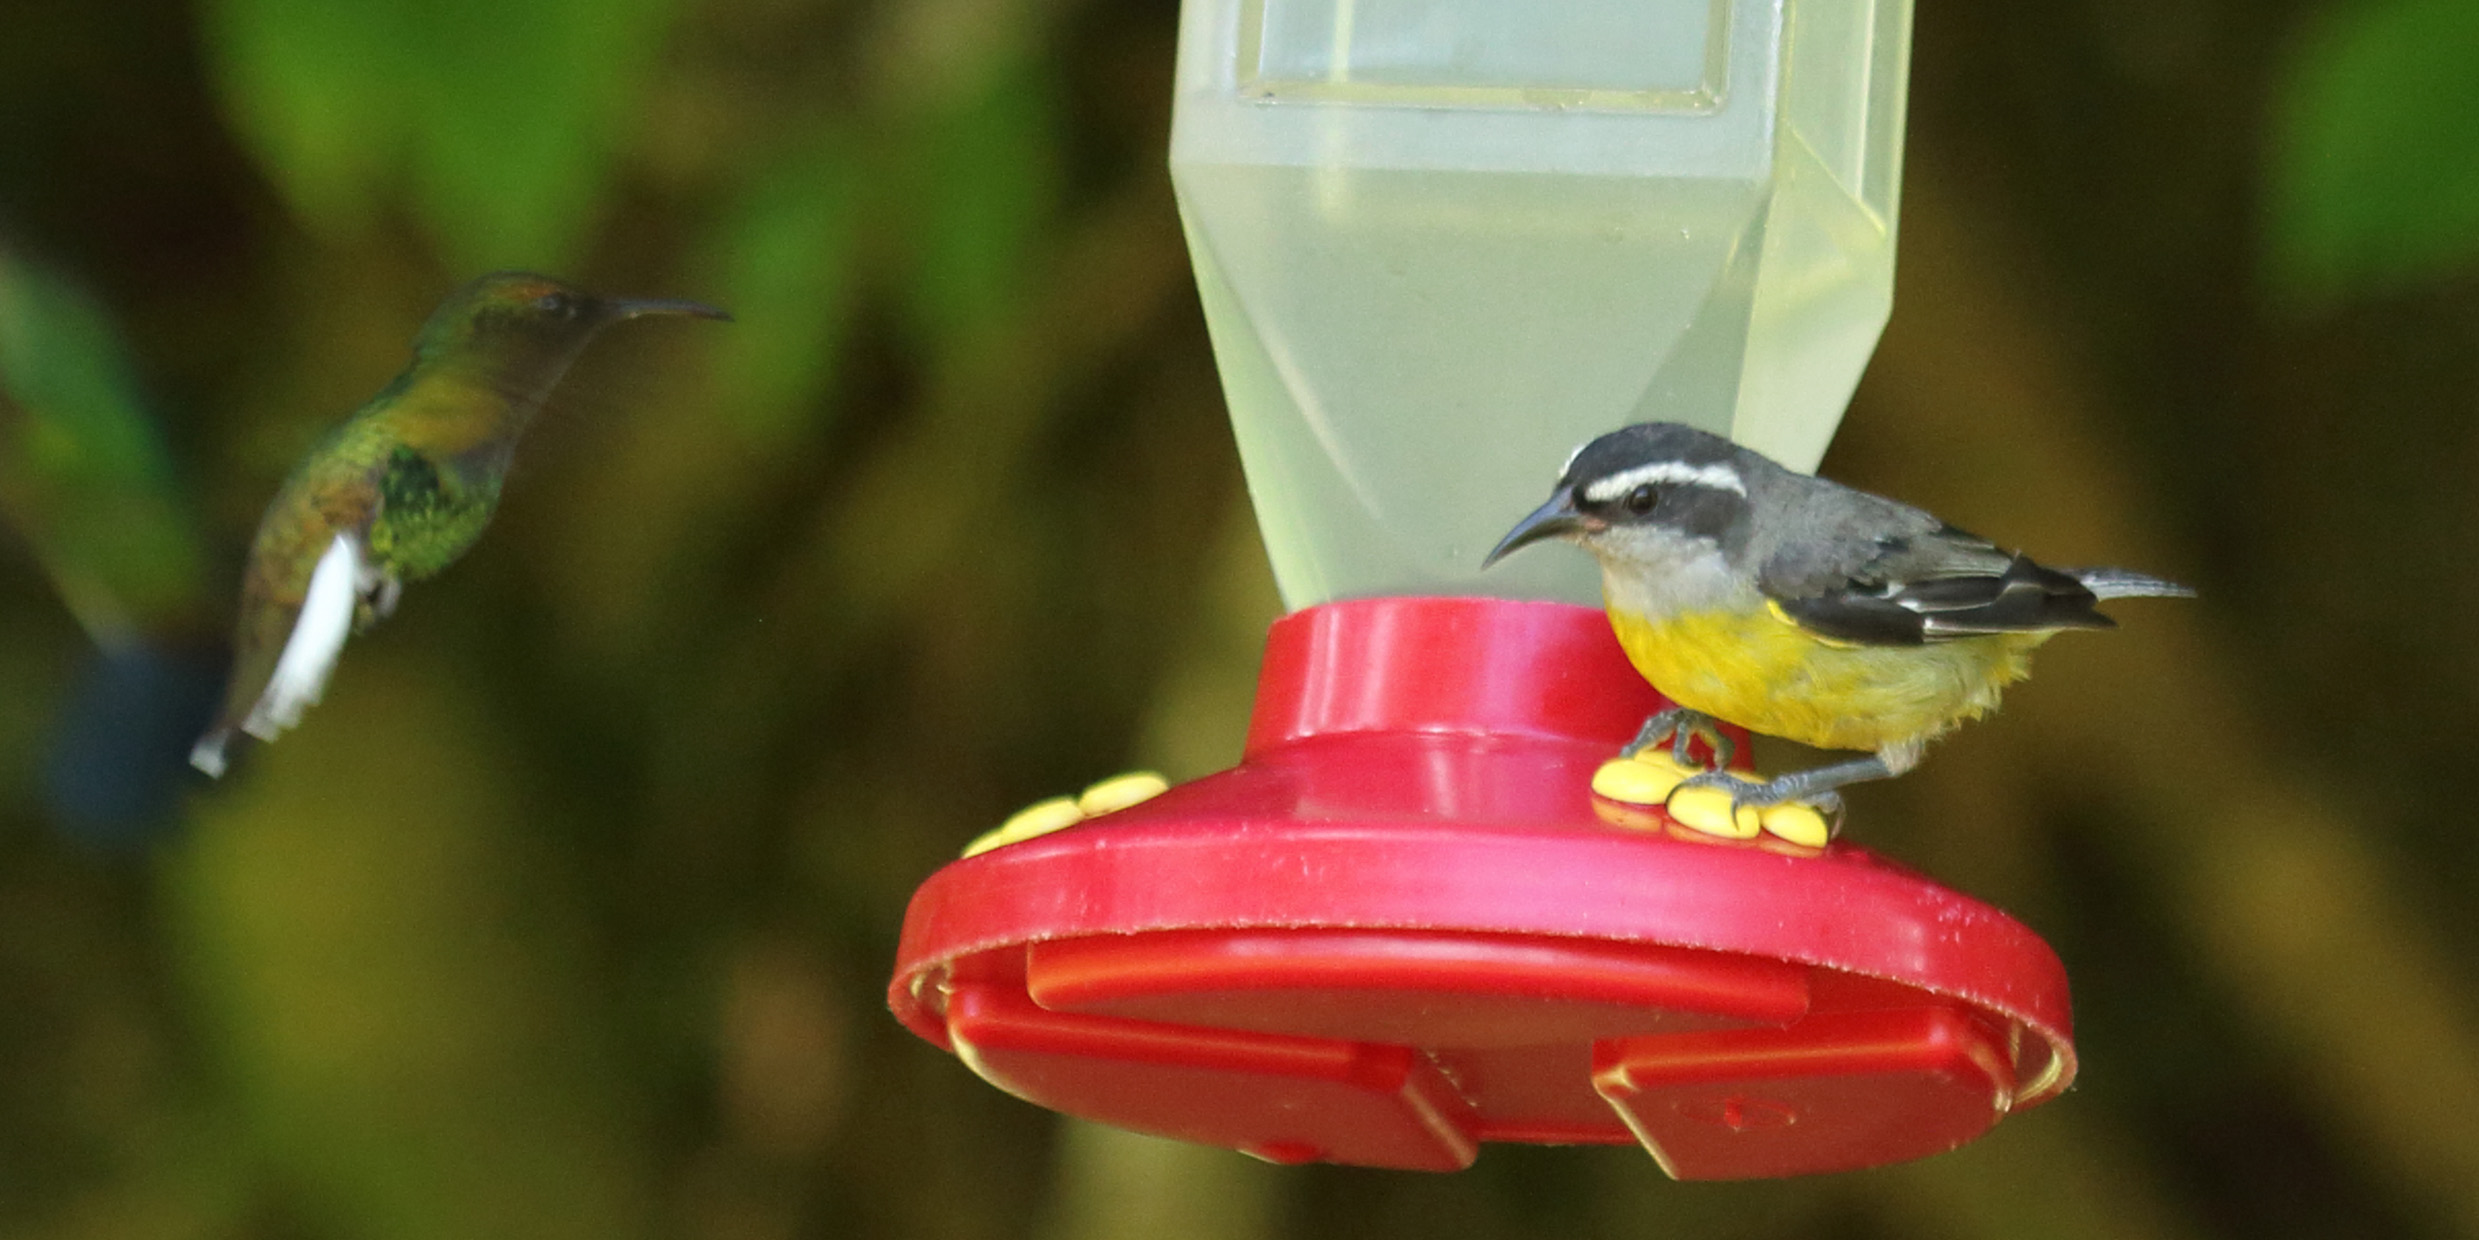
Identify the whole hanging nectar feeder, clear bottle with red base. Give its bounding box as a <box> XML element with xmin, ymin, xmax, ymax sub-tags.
<box><xmin>890</xmin><ymin>0</ymin><xmax>2075</xmax><ymax>1178</ymax></box>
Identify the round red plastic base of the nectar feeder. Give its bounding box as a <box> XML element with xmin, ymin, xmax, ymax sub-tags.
<box><xmin>890</xmin><ymin>598</ymin><xmax>2075</xmax><ymax>1180</ymax></box>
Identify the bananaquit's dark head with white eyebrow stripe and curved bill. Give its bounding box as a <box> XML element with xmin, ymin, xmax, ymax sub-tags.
<box><xmin>1480</xmin><ymin>422</ymin><xmax>1780</xmax><ymax>568</ymax></box>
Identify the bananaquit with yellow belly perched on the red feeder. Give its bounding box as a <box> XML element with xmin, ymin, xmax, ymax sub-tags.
<box><xmin>1482</xmin><ymin>422</ymin><xmax>2194</xmax><ymax>828</ymax></box>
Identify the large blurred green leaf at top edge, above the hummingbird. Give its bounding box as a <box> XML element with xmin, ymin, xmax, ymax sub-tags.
<box><xmin>208</xmin><ymin>0</ymin><xmax>674</xmax><ymax>270</ymax></box>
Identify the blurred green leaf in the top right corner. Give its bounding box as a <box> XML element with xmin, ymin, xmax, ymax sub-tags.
<box><xmin>2266</xmin><ymin>0</ymin><xmax>2479</xmax><ymax>300</ymax></box>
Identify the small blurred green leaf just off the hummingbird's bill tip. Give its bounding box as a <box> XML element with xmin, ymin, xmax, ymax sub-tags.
<box><xmin>716</xmin><ymin>129</ymin><xmax>868</xmax><ymax>441</ymax></box>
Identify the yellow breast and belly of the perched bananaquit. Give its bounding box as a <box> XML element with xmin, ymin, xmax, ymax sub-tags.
<box><xmin>1609</xmin><ymin>608</ymin><xmax>2048</xmax><ymax>749</ymax></box>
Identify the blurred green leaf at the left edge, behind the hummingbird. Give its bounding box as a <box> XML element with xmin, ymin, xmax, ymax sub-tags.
<box><xmin>0</xmin><ymin>253</ymin><xmax>203</xmax><ymax>642</ymax></box>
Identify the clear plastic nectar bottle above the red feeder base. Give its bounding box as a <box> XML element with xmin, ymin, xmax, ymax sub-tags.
<box><xmin>1170</xmin><ymin>0</ymin><xmax>1911</xmax><ymax>608</ymax></box>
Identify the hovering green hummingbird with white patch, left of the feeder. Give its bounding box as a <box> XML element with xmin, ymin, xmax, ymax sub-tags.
<box><xmin>188</xmin><ymin>270</ymin><xmax>731</xmax><ymax>776</ymax></box>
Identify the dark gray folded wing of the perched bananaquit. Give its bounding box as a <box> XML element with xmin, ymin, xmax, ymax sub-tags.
<box><xmin>1758</xmin><ymin>526</ymin><xmax>2117</xmax><ymax>645</ymax></box>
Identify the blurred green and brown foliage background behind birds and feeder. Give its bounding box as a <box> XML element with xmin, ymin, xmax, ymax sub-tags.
<box><xmin>0</xmin><ymin>0</ymin><xmax>2479</xmax><ymax>1240</ymax></box>
